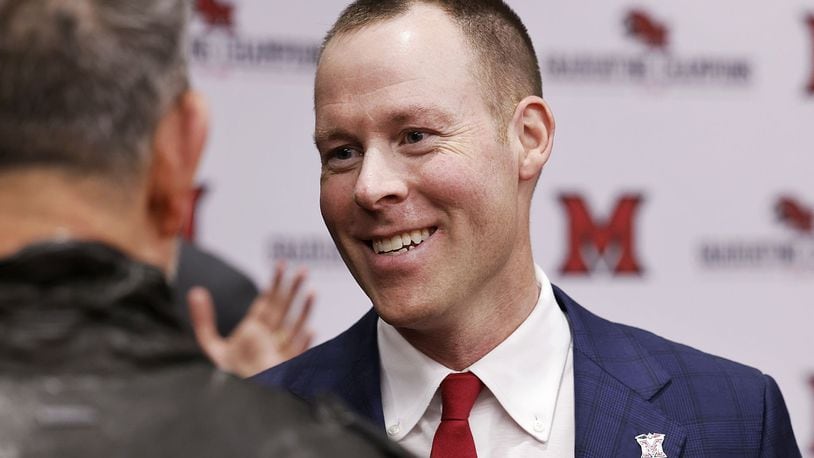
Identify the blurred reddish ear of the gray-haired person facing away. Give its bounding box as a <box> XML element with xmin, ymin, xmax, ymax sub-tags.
<box><xmin>148</xmin><ymin>91</ymin><xmax>209</xmax><ymax>237</ymax></box>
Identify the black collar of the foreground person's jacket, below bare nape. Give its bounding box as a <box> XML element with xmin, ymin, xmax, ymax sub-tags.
<box><xmin>0</xmin><ymin>240</ymin><xmax>204</xmax><ymax>374</ymax></box>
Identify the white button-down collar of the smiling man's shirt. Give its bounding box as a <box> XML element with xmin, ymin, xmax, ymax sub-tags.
<box><xmin>377</xmin><ymin>265</ymin><xmax>571</xmax><ymax>442</ymax></box>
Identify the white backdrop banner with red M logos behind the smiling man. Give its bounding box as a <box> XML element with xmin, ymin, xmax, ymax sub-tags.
<box><xmin>190</xmin><ymin>0</ymin><xmax>814</xmax><ymax>450</ymax></box>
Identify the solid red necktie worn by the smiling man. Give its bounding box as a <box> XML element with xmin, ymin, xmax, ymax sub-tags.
<box><xmin>430</xmin><ymin>372</ymin><xmax>483</xmax><ymax>458</ymax></box>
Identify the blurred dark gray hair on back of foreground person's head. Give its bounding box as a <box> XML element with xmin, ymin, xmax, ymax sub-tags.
<box><xmin>0</xmin><ymin>0</ymin><xmax>188</xmax><ymax>178</ymax></box>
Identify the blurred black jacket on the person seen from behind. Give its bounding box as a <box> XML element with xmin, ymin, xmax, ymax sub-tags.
<box><xmin>0</xmin><ymin>242</ymin><xmax>406</xmax><ymax>458</ymax></box>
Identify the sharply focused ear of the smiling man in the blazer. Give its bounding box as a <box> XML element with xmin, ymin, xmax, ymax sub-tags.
<box><xmin>509</xmin><ymin>96</ymin><xmax>554</xmax><ymax>180</ymax></box>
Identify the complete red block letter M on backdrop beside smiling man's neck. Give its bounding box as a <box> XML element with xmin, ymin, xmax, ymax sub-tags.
<box><xmin>560</xmin><ymin>194</ymin><xmax>643</xmax><ymax>275</ymax></box>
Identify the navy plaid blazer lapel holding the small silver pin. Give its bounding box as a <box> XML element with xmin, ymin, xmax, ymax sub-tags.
<box><xmin>554</xmin><ymin>287</ymin><xmax>686</xmax><ymax>458</ymax></box>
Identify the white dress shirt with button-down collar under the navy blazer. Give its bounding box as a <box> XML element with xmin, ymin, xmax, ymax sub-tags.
<box><xmin>377</xmin><ymin>266</ymin><xmax>575</xmax><ymax>458</ymax></box>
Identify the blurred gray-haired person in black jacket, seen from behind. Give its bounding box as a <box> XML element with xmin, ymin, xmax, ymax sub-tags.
<box><xmin>0</xmin><ymin>0</ymin><xmax>402</xmax><ymax>457</ymax></box>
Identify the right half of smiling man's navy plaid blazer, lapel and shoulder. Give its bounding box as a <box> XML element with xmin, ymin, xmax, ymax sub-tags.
<box><xmin>555</xmin><ymin>287</ymin><xmax>800</xmax><ymax>457</ymax></box>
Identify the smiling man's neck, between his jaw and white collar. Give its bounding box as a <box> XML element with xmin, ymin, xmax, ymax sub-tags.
<box><xmin>398</xmin><ymin>255</ymin><xmax>540</xmax><ymax>370</ymax></box>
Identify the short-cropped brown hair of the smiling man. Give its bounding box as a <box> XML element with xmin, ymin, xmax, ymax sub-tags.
<box><xmin>322</xmin><ymin>0</ymin><xmax>543</xmax><ymax>131</ymax></box>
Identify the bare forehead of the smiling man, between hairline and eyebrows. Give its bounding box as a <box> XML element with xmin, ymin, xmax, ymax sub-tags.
<box><xmin>314</xmin><ymin>7</ymin><xmax>478</xmax><ymax>111</ymax></box>
